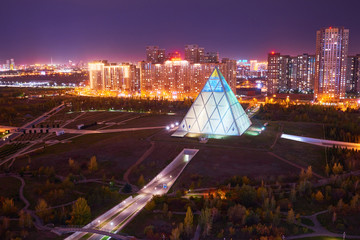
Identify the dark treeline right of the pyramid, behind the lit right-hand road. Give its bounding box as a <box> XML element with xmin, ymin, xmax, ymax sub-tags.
<box><xmin>256</xmin><ymin>104</ymin><xmax>360</xmax><ymax>142</ymax></box>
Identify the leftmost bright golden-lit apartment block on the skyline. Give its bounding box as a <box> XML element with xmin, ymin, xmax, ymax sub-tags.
<box><xmin>89</xmin><ymin>60</ymin><xmax>140</xmax><ymax>93</ymax></box>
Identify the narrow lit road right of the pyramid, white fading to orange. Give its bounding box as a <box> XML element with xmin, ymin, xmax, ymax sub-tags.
<box><xmin>281</xmin><ymin>133</ymin><xmax>360</xmax><ymax>149</ymax></box>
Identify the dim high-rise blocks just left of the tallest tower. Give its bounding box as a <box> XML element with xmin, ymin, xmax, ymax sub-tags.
<box><xmin>267</xmin><ymin>52</ymin><xmax>315</xmax><ymax>94</ymax></box>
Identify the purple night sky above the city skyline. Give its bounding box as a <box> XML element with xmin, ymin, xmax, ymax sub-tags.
<box><xmin>0</xmin><ymin>0</ymin><xmax>360</xmax><ymax>64</ymax></box>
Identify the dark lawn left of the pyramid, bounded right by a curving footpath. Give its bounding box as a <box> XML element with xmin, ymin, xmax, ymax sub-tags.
<box><xmin>13</xmin><ymin>130</ymin><xmax>159</xmax><ymax>179</ymax></box>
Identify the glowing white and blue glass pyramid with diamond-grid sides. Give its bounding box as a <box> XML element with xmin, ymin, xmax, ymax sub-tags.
<box><xmin>172</xmin><ymin>67</ymin><xmax>251</xmax><ymax>136</ymax></box>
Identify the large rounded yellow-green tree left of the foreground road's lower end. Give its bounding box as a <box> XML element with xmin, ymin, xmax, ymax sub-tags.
<box><xmin>68</xmin><ymin>198</ymin><xmax>91</xmax><ymax>225</ymax></box>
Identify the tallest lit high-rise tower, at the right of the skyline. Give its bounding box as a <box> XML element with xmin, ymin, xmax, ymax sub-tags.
<box><xmin>314</xmin><ymin>27</ymin><xmax>349</xmax><ymax>101</ymax></box>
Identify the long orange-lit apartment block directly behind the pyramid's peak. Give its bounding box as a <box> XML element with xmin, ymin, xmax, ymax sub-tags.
<box><xmin>139</xmin><ymin>59</ymin><xmax>236</xmax><ymax>99</ymax></box>
